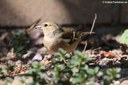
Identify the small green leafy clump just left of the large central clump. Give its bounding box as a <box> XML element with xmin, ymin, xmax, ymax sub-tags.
<box><xmin>25</xmin><ymin>62</ymin><xmax>48</xmax><ymax>85</ymax></box>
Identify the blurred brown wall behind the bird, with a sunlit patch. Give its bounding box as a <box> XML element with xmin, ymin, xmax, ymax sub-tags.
<box><xmin>0</xmin><ymin>0</ymin><xmax>128</xmax><ymax>33</ymax></box>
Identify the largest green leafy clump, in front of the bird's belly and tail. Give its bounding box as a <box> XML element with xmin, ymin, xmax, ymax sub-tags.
<box><xmin>52</xmin><ymin>49</ymin><xmax>102</xmax><ymax>85</ymax></box>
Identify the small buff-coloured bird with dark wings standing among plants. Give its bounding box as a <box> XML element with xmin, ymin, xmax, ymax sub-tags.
<box><xmin>36</xmin><ymin>22</ymin><xmax>89</xmax><ymax>54</ymax></box>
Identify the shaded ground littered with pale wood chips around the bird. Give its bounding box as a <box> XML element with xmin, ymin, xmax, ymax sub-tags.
<box><xmin>0</xmin><ymin>29</ymin><xmax>128</xmax><ymax>85</ymax></box>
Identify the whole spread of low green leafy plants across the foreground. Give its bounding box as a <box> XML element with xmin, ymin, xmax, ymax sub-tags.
<box><xmin>10</xmin><ymin>49</ymin><xmax>120</xmax><ymax>85</ymax></box>
